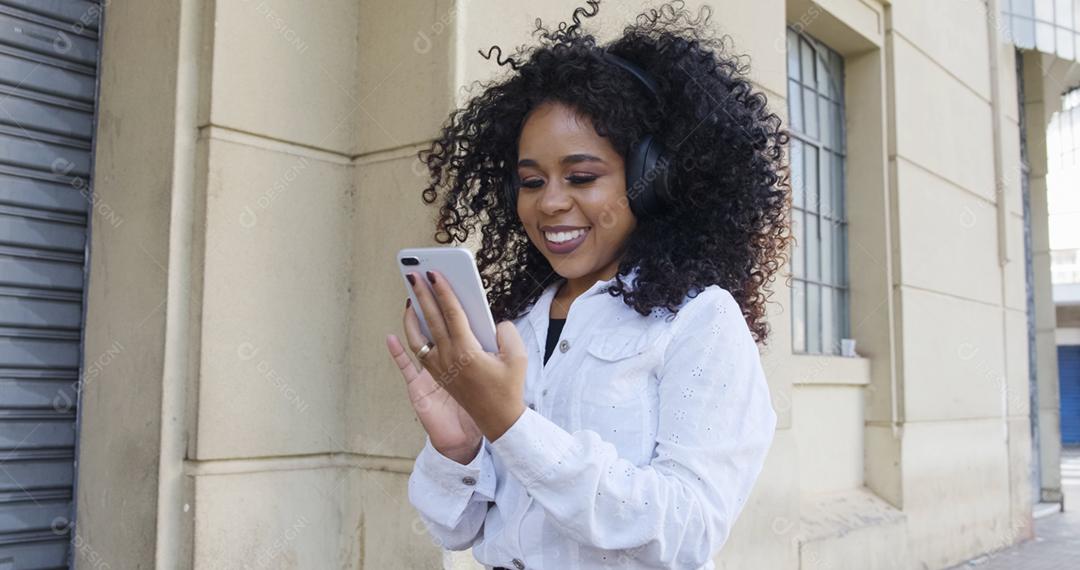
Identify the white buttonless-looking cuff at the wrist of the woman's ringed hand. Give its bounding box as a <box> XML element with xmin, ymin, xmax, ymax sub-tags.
<box><xmin>488</xmin><ymin>408</ymin><xmax>578</xmax><ymax>488</ymax></box>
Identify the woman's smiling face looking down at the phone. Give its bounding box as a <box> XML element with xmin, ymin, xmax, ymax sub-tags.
<box><xmin>517</xmin><ymin>103</ymin><xmax>637</xmax><ymax>286</ymax></box>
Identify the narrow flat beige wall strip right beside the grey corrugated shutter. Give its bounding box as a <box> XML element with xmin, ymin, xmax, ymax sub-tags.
<box><xmin>76</xmin><ymin>2</ymin><xmax>179</xmax><ymax>568</ymax></box>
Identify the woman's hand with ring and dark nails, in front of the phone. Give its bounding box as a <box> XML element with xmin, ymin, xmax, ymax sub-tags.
<box><xmin>405</xmin><ymin>271</ymin><xmax>528</xmax><ymax>442</ymax></box>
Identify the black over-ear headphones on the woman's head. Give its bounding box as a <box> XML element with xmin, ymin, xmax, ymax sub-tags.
<box><xmin>503</xmin><ymin>50</ymin><xmax>672</xmax><ymax>220</ymax></box>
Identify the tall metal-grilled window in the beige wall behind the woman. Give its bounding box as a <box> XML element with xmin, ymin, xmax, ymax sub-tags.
<box><xmin>787</xmin><ymin>28</ymin><xmax>850</xmax><ymax>354</ymax></box>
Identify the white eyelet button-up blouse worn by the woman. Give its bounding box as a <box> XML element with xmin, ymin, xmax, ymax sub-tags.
<box><xmin>408</xmin><ymin>264</ymin><xmax>777</xmax><ymax>570</ymax></box>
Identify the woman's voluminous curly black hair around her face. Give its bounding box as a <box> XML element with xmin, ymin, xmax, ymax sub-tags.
<box><xmin>418</xmin><ymin>0</ymin><xmax>793</xmax><ymax>343</ymax></box>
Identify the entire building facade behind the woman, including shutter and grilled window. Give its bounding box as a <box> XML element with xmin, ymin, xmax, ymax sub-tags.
<box><xmin>0</xmin><ymin>0</ymin><xmax>1080</xmax><ymax>570</ymax></box>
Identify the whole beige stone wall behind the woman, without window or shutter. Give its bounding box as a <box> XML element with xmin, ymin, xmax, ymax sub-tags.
<box><xmin>78</xmin><ymin>0</ymin><xmax>1056</xmax><ymax>570</ymax></box>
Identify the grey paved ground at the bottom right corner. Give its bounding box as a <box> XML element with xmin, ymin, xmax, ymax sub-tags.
<box><xmin>950</xmin><ymin>447</ymin><xmax>1080</xmax><ymax>570</ymax></box>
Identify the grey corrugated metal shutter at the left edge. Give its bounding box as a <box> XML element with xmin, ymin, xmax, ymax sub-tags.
<box><xmin>0</xmin><ymin>0</ymin><xmax>100</xmax><ymax>569</ymax></box>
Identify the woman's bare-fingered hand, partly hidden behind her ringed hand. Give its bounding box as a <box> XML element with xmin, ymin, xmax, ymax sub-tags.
<box><xmin>387</xmin><ymin>328</ymin><xmax>484</xmax><ymax>464</ymax></box>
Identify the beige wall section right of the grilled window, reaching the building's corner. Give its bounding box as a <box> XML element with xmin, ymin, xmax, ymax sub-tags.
<box><xmin>888</xmin><ymin>1</ymin><xmax>1030</xmax><ymax>568</ymax></box>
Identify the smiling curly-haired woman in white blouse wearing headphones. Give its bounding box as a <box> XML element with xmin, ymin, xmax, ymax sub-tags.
<box><xmin>387</xmin><ymin>1</ymin><xmax>791</xmax><ymax>570</ymax></box>
